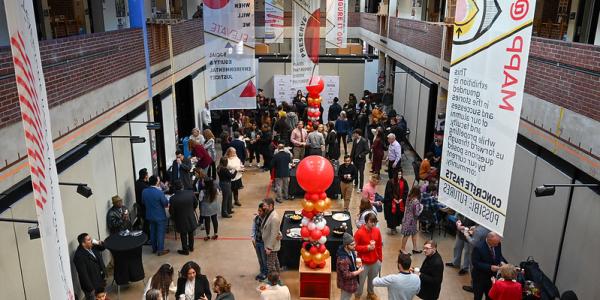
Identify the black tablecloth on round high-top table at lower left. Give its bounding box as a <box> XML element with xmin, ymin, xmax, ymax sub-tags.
<box><xmin>104</xmin><ymin>234</ymin><xmax>148</xmax><ymax>285</ymax></box>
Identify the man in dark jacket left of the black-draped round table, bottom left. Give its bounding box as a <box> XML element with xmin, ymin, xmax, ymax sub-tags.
<box><xmin>73</xmin><ymin>233</ymin><xmax>106</xmax><ymax>300</ymax></box>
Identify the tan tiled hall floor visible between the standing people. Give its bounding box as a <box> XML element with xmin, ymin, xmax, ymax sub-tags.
<box><xmin>110</xmin><ymin>151</ymin><xmax>472</xmax><ymax>300</ymax></box>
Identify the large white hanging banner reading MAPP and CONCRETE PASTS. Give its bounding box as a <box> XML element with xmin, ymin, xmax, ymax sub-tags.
<box><xmin>439</xmin><ymin>0</ymin><xmax>535</xmax><ymax>235</ymax></box>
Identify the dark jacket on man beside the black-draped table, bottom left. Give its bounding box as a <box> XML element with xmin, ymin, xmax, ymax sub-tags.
<box><xmin>73</xmin><ymin>245</ymin><xmax>106</xmax><ymax>293</ymax></box>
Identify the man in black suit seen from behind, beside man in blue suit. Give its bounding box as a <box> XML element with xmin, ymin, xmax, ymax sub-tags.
<box><xmin>169</xmin><ymin>181</ymin><xmax>198</xmax><ymax>255</ymax></box>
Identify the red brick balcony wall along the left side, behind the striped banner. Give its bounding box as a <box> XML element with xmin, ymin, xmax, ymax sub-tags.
<box><xmin>0</xmin><ymin>19</ymin><xmax>204</xmax><ymax>128</ymax></box>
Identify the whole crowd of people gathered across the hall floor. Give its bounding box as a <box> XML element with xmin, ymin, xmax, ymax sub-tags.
<box><xmin>74</xmin><ymin>90</ymin><xmax>519</xmax><ymax>300</ymax></box>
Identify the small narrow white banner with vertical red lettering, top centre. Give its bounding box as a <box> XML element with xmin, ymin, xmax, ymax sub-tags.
<box><xmin>325</xmin><ymin>0</ymin><xmax>348</xmax><ymax>48</ymax></box>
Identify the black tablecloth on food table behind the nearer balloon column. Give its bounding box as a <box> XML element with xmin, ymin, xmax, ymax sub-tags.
<box><xmin>278</xmin><ymin>210</ymin><xmax>352</xmax><ymax>270</ymax></box>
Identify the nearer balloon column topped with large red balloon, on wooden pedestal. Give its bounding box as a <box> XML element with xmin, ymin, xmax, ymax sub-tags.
<box><xmin>296</xmin><ymin>155</ymin><xmax>334</xmax><ymax>269</ymax></box>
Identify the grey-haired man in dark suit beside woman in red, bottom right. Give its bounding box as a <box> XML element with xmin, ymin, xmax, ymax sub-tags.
<box><xmin>471</xmin><ymin>232</ymin><xmax>506</xmax><ymax>300</ymax></box>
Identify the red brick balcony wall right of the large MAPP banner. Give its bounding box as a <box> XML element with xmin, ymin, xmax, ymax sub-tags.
<box><xmin>525</xmin><ymin>37</ymin><xmax>600</xmax><ymax>121</ymax></box>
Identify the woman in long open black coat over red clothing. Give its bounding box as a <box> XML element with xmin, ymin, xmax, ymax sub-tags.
<box><xmin>383</xmin><ymin>170</ymin><xmax>410</xmax><ymax>234</ymax></box>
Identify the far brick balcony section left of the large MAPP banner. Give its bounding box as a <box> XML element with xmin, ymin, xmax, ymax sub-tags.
<box><xmin>389</xmin><ymin>18</ymin><xmax>444</xmax><ymax>57</ymax></box>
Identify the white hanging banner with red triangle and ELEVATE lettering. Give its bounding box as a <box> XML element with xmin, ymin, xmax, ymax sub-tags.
<box><xmin>204</xmin><ymin>0</ymin><xmax>256</xmax><ymax>110</ymax></box>
